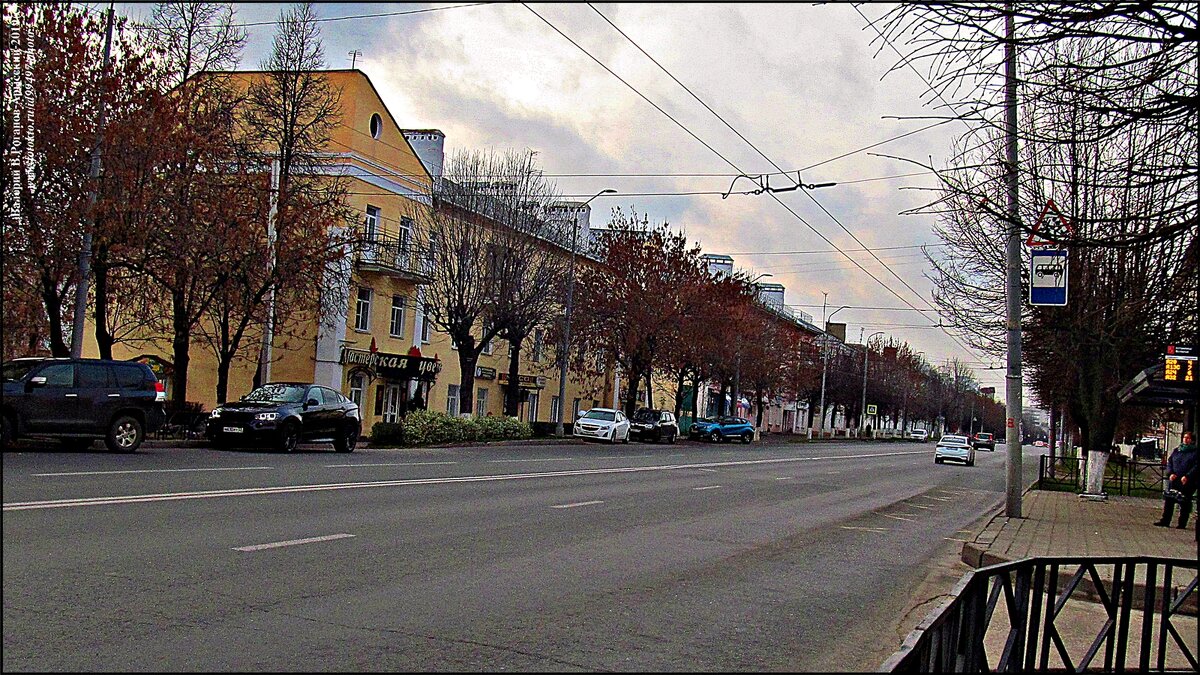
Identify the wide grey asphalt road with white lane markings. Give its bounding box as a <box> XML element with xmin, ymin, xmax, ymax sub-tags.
<box><xmin>4</xmin><ymin>443</ymin><xmax>1036</xmax><ymax>671</ymax></box>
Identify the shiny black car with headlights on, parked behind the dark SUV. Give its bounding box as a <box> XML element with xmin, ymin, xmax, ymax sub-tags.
<box><xmin>205</xmin><ymin>382</ymin><xmax>362</xmax><ymax>453</ymax></box>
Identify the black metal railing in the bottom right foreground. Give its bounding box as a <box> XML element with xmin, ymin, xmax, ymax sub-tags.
<box><xmin>880</xmin><ymin>557</ymin><xmax>1198</xmax><ymax>673</ymax></box>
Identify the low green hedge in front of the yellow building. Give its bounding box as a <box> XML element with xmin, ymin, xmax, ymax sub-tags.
<box><xmin>371</xmin><ymin>403</ymin><xmax>533</xmax><ymax>446</ymax></box>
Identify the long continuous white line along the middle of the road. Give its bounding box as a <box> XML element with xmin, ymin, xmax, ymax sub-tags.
<box><xmin>4</xmin><ymin>450</ymin><xmax>931</xmax><ymax>512</ymax></box>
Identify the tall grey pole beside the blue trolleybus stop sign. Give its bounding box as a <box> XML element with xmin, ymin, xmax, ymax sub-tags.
<box><xmin>1004</xmin><ymin>1</ymin><xmax>1024</xmax><ymax>518</ymax></box>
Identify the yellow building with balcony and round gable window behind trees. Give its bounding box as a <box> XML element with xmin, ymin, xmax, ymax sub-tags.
<box><xmin>84</xmin><ymin>70</ymin><xmax>613</xmax><ymax>434</ymax></box>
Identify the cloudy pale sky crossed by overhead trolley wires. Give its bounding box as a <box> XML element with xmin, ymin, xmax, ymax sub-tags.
<box><xmin>105</xmin><ymin>2</ymin><xmax>1004</xmax><ymax>389</ymax></box>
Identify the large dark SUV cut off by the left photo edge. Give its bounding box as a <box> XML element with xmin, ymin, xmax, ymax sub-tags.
<box><xmin>0</xmin><ymin>358</ymin><xmax>167</xmax><ymax>453</ymax></box>
